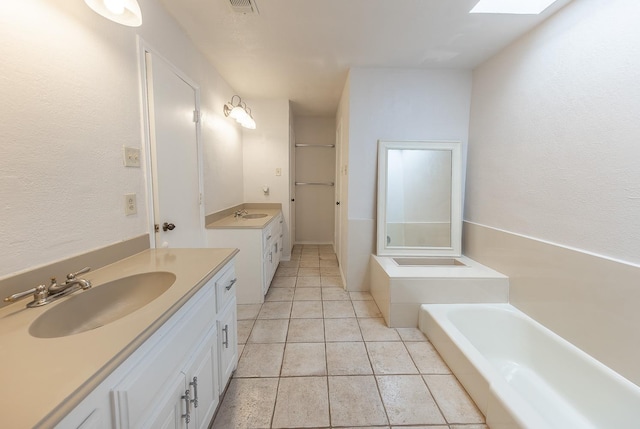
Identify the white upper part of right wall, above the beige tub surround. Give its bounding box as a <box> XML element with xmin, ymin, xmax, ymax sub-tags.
<box><xmin>465</xmin><ymin>0</ymin><xmax>640</xmax><ymax>264</ymax></box>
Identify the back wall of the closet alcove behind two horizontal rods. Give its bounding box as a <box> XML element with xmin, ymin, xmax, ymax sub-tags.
<box><xmin>294</xmin><ymin>116</ymin><xmax>336</xmax><ymax>244</ymax></box>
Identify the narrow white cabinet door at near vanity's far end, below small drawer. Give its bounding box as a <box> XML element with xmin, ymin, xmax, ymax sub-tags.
<box><xmin>218</xmin><ymin>299</ymin><xmax>238</xmax><ymax>393</ymax></box>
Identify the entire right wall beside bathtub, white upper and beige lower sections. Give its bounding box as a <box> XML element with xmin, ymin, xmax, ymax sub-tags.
<box><xmin>463</xmin><ymin>0</ymin><xmax>640</xmax><ymax>385</ymax></box>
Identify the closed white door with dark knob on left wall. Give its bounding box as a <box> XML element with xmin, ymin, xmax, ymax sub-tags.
<box><xmin>145</xmin><ymin>52</ymin><xmax>204</xmax><ymax>247</ymax></box>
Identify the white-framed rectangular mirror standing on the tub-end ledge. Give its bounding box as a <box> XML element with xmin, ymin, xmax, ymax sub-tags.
<box><xmin>377</xmin><ymin>141</ymin><xmax>462</xmax><ymax>256</ymax></box>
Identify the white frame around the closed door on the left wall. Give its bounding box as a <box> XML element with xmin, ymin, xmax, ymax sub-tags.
<box><xmin>136</xmin><ymin>35</ymin><xmax>205</xmax><ymax>249</ymax></box>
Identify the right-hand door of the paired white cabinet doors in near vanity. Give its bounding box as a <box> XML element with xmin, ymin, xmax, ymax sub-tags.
<box><xmin>184</xmin><ymin>327</ymin><xmax>220</xmax><ymax>429</ymax></box>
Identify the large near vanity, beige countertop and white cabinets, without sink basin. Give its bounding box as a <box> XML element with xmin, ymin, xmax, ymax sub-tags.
<box><xmin>0</xmin><ymin>249</ymin><xmax>238</xmax><ymax>429</ymax></box>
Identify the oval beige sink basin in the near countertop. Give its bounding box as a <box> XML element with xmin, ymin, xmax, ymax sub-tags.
<box><xmin>29</xmin><ymin>271</ymin><xmax>176</xmax><ymax>338</ymax></box>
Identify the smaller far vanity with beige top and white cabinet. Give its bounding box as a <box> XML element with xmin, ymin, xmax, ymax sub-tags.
<box><xmin>206</xmin><ymin>209</ymin><xmax>284</xmax><ymax>304</ymax></box>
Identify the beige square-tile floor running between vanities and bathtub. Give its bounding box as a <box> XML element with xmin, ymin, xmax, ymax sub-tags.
<box><xmin>213</xmin><ymin>245</ymin><xmax>488</xmax><ymax>429</ymax></box>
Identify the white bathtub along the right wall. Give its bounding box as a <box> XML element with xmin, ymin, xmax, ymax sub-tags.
<box><xmin>419</xmin><ymin>304</ymin><xmax>640</xmax><ymax>429</ymax></box>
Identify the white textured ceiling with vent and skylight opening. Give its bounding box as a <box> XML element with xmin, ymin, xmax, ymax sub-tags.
<box><xmin>161</xmin><ymin>0</ymin><xmax>571</xmax><ymax>116</ymax></box>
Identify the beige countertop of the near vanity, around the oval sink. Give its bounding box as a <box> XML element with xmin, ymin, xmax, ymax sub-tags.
<box><xmin>0</xmin><ymin>249</ymin><xmax>238</xmax><ymax>428</ymax></box>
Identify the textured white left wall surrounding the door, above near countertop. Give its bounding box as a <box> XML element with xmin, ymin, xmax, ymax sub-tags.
<box><xmin>0</xmin><ymin>0</ymin><xmax>242</xmax><ymax>277</ymax></box>
